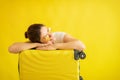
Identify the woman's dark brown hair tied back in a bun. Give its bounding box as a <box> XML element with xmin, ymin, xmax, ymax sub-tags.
<box><xmin>25</xmin><ymin>24</ymin><xmax>44</xmax><ymax>43</ymax></box>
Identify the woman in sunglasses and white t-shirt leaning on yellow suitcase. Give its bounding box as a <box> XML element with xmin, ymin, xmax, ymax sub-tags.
<box><xmin>8</xmin><ymin>24</ymin><xmax>85</xmax><ymax>53</ymax></box>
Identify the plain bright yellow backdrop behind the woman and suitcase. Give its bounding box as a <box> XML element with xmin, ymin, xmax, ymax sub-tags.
<box><xmin>0</xmin><ymin>0</ymin><xmax>120</xmax><ymax>80</ymax></box>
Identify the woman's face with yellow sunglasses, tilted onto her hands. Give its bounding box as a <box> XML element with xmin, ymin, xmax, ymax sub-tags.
<box><xmin>40</xmin><ymin>26</ymin><xmax>54</xmax><ymax>43</ymax></box>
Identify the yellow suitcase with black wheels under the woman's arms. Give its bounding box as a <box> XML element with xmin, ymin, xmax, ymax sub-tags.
<box><xmin>19</xmin><ymin>50</ymin><xmax>85</xmax><ymax>80</ymax></box>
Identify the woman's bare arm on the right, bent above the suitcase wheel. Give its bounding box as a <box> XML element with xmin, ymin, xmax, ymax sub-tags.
<box><xmin>36</xmin><ymin>34</ymin><xmax>85</xmax><ymax>51</ymax></box>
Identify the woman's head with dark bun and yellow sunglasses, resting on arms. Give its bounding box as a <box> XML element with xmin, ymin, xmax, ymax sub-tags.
<box><xmin>25</xmin><ymin>24</ymin><xmax>52</xmax><ymax>43</ymax></box>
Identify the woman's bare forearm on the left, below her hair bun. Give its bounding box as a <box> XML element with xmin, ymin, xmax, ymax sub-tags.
<box><xmin>8</xmin><ymin>42</ymin><xmax>39</xmax><ymax>53</ymax></box>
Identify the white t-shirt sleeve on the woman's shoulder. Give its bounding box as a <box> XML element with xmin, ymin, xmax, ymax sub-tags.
<box><xmin>53</xmin><ymin>32</ymin><xmax>66</xmax><ymax>43</ymax></box>
